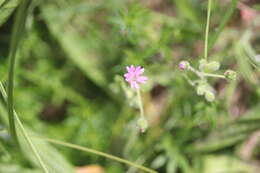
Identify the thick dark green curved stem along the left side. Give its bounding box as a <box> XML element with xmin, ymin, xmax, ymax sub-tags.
<box><xmin>7</xmin><ymin>0</ymin><xmax>29</xmax><ymax>148</ymax></box>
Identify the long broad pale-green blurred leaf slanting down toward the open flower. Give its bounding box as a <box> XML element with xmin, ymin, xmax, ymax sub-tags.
<box><xmin>41</xmin><ymin>3</ymin><xmax>107</xmax><ymax>87</ymax></box>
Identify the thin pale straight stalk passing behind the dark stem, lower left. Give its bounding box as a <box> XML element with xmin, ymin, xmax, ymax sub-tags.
<box><xmin>0</xmin><ymin>81</ymin><xmax>49</xmax><ymax>173</ymax></box>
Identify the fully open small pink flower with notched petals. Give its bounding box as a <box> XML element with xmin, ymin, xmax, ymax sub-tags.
<box><xmin>124</xmin><ymin>65</ymin><xmax>148</xmax><ymax>89</ymax></box>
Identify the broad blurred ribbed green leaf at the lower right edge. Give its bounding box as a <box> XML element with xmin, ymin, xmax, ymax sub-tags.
<box><xmin>187</xmin><ymin>105</ymin><xmax>260</xmax><ymax>153</ymax></box>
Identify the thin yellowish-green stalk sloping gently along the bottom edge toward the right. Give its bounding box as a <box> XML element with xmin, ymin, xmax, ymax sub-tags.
<box><xmin>32</xmin><ymin>136</ymin><xmax>157</xmax><ymax>173</ymax></box>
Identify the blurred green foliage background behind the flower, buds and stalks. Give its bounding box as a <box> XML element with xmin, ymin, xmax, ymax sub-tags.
<box><xmin>0</xmin><ymin>0</ymin><xmax>260</xmax><ymax>173</ymax></box>
